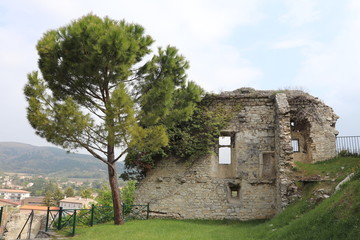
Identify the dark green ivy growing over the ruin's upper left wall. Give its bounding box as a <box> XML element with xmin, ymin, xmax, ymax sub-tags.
<box><xmin>121</xmin><ymin>94</ymin><xmax>235</xmax><ymax>180</ymax></box>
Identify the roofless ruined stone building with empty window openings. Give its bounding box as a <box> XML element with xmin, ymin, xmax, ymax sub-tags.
<box><xmin>136</xmin><ymin>88</ymin><xmax>338</xmax><ymax>220</ymax></box>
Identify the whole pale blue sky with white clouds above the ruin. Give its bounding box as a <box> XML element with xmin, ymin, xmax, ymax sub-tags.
<box><xmin>0</xmin><ymin>0</ymin><xmax>360</xmax><ymax>150</ymax></box>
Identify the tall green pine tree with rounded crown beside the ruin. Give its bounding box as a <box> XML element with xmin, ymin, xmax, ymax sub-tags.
<box><xmin>24</xmin><ymin>14</ymin><xmax>202</xmax><ymax>224</ymax></box>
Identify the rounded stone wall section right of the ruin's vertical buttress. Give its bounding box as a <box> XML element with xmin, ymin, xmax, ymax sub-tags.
<box><xmin>288</xmin><ymin>93</ymin><xmax>339</xmax><ymax>162</ymax></box>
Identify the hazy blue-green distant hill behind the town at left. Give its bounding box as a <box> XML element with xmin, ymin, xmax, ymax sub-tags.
<box><xmin>0</xmin><ymin>142</ymin><xmax>124</xmax><ymax>178</ymax></box>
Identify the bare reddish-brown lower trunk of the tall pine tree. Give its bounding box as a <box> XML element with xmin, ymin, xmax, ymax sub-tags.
<box><xmin>108</xmin><ymin>147</ymin><xmax>124</xmax><ymax>225</ymax></box>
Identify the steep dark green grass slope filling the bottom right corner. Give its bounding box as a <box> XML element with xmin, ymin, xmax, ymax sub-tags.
<box><xmin>259</xmin><ymin>179</ymin><xmax>360</xmax><ymax>240</ymax></box>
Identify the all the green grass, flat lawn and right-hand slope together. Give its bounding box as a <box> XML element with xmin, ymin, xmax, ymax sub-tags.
<box><xmin>73</xmin><ymin>158</ymin><xmax>360</xmax><ymax>240</ymax></box>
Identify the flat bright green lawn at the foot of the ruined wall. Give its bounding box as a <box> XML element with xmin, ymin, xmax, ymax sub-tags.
<box><xmin>73</xmin><ymin>219</ymin><xmax>261</xmax><ymax>240</ymax></box>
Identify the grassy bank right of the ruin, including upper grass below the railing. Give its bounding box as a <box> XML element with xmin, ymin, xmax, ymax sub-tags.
<box><xmin>258</xmin><ymin>157</ymin><xmax>360</xmax><ymax>240</ymax></box>
